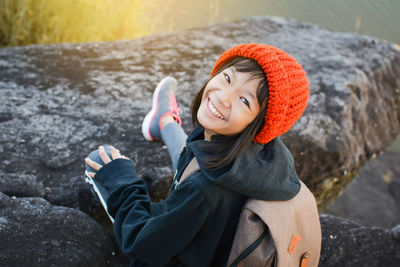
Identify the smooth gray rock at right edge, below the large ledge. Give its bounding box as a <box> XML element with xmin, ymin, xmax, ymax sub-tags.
<box><xmin>324</xmin><ymin>151</ymin><xmax>400</xmax><ymax>228</ymax></box>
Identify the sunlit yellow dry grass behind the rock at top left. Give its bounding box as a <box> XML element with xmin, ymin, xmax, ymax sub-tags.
<box><xmin>0</xmin><ymin>0</ymin><xmax>152</xmax><ymax>46</ymax></box>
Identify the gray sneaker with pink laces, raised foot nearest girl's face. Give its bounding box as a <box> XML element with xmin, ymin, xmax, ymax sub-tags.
<box><xmin>142</xmin><ymin>76</ymin><xmax>182</xmax><ymax>141</ymax></box>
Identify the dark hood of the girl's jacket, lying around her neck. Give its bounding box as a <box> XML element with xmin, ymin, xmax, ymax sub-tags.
<box><xmin>186</xmin><ymin>127</ymin><xmax>300</xmax><ymax>200</ymax></box>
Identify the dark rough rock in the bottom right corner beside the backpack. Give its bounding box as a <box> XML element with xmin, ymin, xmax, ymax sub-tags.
<box><xmin>319</xmin><ymin>214</ymin><xmax>400</xmax><ymax>267</ymax></box>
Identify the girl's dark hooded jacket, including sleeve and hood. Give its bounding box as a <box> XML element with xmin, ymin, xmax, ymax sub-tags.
<box><xmin>95</xmin><ymin>128</ymin><xmax>300</xmax><ymax>267</ymax></box>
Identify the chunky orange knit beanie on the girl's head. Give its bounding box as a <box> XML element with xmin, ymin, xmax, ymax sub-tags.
<box><xmin>211</xmin><ymin>44</ymin><xmax>309</xmax><ymax>144</ymax></box>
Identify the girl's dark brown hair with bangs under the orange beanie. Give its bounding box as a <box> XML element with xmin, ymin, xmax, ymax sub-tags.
<box><xmin>192</xmin><ymin>57</ymin><xmax>268</xmax><ymax>169</ymax></box>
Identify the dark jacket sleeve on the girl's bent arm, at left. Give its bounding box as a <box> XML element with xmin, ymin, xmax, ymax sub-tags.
<box><xmin>95</xmin><ymin>159</ymin><xmax>209</xmax><ymax>266</ymax></box>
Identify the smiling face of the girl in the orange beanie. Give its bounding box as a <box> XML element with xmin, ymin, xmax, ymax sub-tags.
<box><xmin>197</xmin><ymin>67</ymin><xmax>260</xmax><ymax>141</ymax></box>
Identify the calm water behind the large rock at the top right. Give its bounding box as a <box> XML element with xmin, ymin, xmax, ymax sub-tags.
<box><xmin>150</xmin><ymin>0</ymin><xmax>400</xmax><ymax>44</ymax></box>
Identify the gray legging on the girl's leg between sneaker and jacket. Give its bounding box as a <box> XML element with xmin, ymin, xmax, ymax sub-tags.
<box><xmin>161</xmin><ymin>122</ymin><xmax>187</xmax><ymax>170</ymax></box>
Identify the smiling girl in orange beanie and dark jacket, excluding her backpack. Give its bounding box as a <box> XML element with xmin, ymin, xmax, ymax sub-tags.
<box><xmin>86</xmin><ymin>44</ymin><xmax>309</xmax><ymax>267</ymax></box>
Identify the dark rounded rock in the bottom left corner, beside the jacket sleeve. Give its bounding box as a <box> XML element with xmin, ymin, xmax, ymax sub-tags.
<box><xmin>0</xmin><ymin>192</ymin><xmax>126</xmax><ymax>266</ymax></box>
